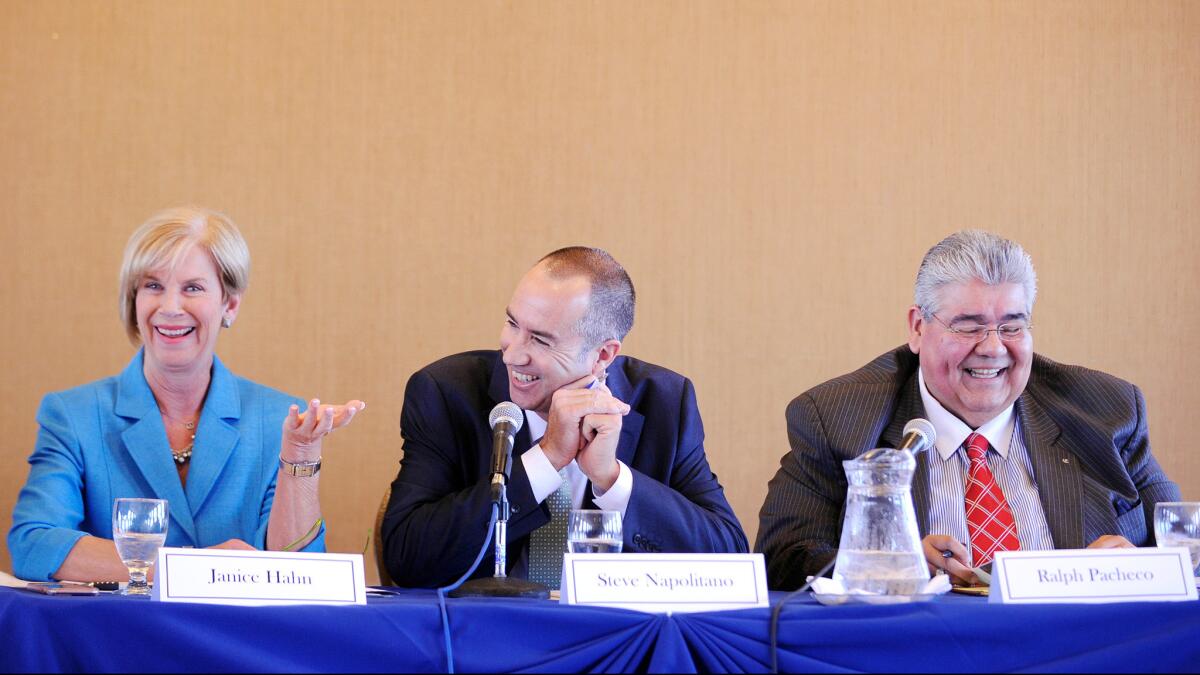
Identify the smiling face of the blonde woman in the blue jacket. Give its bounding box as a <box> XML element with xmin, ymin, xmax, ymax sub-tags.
<box><xmin>134</xmin><ymin>245</ymin><xmax>241</xmax><ymax>372</ymax></box>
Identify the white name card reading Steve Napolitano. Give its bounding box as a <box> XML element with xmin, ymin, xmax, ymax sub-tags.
<box><xmin>560</xmin><ymin>554</ymin><xmax>768</xmax><ymax>613</ymax></box>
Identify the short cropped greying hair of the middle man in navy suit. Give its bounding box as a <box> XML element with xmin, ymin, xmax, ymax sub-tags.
<box><xmin>538</xmin><ymin>246</ymin><xmax>637</xmax><ymax>350</ymax></box>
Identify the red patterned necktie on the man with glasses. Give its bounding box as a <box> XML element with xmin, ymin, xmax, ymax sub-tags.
<box><xmin>966</xmin><ymin>434</ymin><xmax>1021</xmax><ymax>567</ymax></box>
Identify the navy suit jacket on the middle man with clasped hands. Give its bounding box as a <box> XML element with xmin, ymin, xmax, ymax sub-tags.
<box><xmin>382</xmin><ymin>351</ymin><xmax>748</xmax><ymax>587</ymax></box>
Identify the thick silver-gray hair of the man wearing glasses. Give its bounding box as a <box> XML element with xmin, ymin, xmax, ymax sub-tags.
<box><xmin>913</xmin><ymin>229</ymin><xmax>1038</xmax><ymax>317</ymax></box>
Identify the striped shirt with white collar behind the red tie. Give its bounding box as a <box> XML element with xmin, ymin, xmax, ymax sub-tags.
<box><xmin>917</xmin><ymin>370</ymin><xmax>1054</xmax><ymax>557</ymax></box>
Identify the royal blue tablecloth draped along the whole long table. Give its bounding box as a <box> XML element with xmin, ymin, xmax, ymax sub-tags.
<box><xmin>0</xmin><ymin>589</ymin><xmax>1200</xmax><ymax>673</ymax></box>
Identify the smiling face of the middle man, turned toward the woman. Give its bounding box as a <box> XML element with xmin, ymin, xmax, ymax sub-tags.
<box><xmin>500</xmin><ymin>265</ymin><xmax>620</xmax><ymax>416</ymax></box>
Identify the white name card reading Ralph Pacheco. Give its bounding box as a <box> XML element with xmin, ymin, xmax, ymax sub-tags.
<box><xmin>988</xmin><ymin>548</ymin><xmax>1196</xmax><ymax>603</ymax></box>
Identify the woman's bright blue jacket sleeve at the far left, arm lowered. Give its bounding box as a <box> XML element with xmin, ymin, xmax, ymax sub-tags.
<box><xmin>8</xmin><ymin>394</ymin><xmax>86</xmax><ymax>581</ymax></box>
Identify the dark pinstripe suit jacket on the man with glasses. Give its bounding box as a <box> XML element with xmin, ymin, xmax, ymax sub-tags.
<box><xmin>755</xmin><ymin>346</ymin><xmax>1180</xmax><ymax>590</ymax></box>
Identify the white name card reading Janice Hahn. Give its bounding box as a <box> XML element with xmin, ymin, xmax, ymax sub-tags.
<box><xmin>152</xmin><ymin>548</ymin><xmax>367</xmax><ymax>605</ymax></box>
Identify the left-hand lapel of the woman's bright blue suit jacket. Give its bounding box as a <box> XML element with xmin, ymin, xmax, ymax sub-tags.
<box><xmin>113</xmin><ymin>351</ymin><xmax>196</xmax><ymax>542</ymax></box>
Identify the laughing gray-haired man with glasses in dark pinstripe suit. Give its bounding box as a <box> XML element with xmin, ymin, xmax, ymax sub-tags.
<box><xmin>755</xmin><ymin>231</ymin><xmax>1180</xmax><ymax>590</ymax></box>
